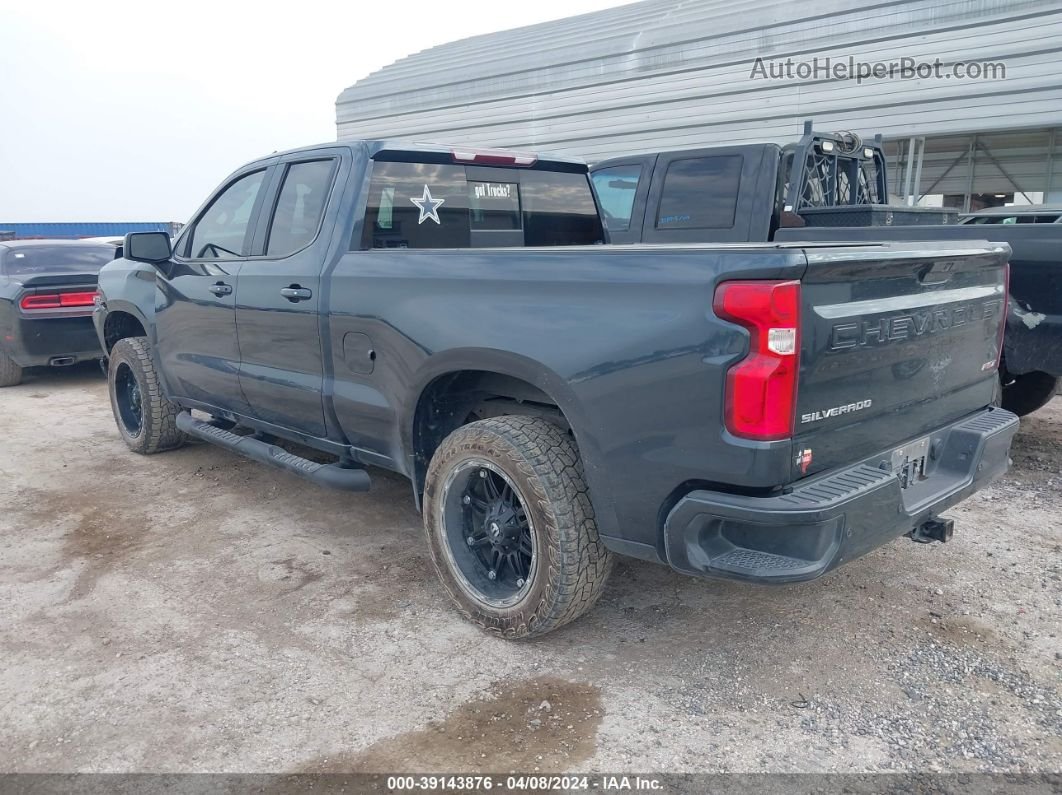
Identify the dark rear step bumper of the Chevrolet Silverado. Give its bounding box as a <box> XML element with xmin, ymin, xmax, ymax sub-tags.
<box><xmin>665</xmin><ymin>409</ymin><xmax>1017</xmax><ymax>583</ymax></box>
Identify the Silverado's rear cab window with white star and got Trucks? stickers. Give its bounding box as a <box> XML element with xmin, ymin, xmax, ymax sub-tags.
<box><xmin>360</xmin><ymin>160</ymin><xmax>604</xmax><ymax>248</ymax></box>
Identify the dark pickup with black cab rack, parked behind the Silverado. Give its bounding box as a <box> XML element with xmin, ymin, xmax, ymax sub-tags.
<box><xmin>593</xmin><ymin>127</ymin><xmax>1062</xmax><ymax>415</ymax></box>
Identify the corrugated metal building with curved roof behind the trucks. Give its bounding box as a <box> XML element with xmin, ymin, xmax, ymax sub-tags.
<box><xmin>337</xmin><ymin>0</ymin><xmax>1062</xmax><ymax>208</ymax></box>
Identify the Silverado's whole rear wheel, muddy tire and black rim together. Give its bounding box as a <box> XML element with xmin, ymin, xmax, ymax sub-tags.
<box><xmin>424</xmin><ymin>416</ymin><xmax>613</xmax><ymax>639</ymax></box>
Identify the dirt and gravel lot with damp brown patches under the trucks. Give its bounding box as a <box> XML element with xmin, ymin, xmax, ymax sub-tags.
<box><xmin>0</xmin><ymin>368</ymin><xmax>1062</xmax><ymax>773</ymax></box>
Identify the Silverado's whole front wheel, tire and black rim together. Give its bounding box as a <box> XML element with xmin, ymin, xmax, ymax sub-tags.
<box><xmin>107</xmin><ymin>336</ymin><xmax>186</xmax><ymax>455</ymax></box>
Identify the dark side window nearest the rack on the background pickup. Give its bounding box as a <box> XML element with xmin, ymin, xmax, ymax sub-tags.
<box><xmin>656</xmin><ymin>155</ymin><xmax>742</xmax><ymax>230</ymax></box>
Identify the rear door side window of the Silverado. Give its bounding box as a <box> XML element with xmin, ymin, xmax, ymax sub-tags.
<box><xmin>266</xmin><ymin>159</ymin><xmax>336</xmax><ymax>257</ymax></box>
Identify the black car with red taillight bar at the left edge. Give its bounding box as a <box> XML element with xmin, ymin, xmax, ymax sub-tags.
<box><xmin>0</xmin><ymin>240</ymin><xmax>118</xmax><ymax>386</ymax></box>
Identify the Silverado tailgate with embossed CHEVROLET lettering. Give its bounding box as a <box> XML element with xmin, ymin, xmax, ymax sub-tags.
<box><xmin>792</xmin><ymin>242</ymin><xmax>1010</xmax><ymax>480</ymax></box>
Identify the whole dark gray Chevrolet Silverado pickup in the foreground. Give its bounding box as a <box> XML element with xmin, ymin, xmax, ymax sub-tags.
<box><xmin>95</xmin><ymin>142</ymin><xmax>1017</xmax><ymax>638</ymax></box>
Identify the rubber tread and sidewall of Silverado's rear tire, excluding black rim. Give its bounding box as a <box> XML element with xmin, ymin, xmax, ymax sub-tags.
<box><xmin>424</xmin><ymin>416</ymin><xmax>613</xmax><ymax>639</ymax></box>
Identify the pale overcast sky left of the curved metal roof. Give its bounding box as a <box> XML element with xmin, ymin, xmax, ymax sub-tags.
<box><xmin>0</xmin><ymin>0</ymin><xmax>621</xmax><ymax>223</ymax></box>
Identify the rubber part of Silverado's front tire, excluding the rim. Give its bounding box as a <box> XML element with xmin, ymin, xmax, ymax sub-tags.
<box><xmin>107</xmin><ymin>336</ymin><xmax>187</xmax><ymax>455</ymax></box>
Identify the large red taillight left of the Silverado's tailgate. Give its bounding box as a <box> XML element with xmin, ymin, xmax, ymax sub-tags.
<box><xmin>714</xmin><ymin>281</ymin><xmax>800</xmax><ymax>442</ymax></box>
